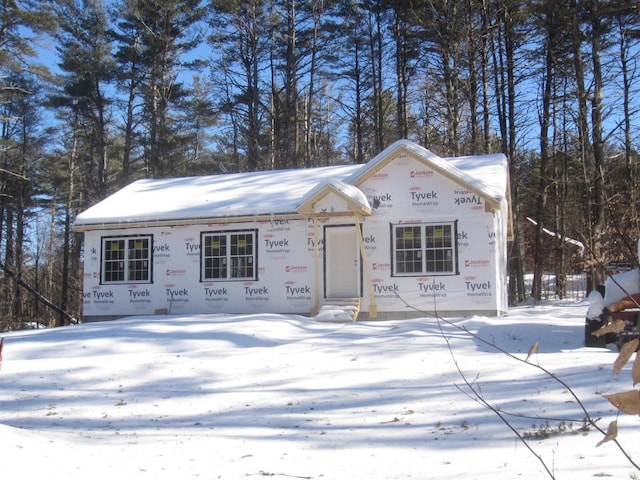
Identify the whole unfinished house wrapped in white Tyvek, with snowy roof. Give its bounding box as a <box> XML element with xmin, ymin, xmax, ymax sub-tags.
<box><xmin>74</xmin><ymin>140</ymin><xmax>511</xmax><ymax>321</ymax></box>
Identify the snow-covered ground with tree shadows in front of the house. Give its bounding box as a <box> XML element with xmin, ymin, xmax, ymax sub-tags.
<box><xmin>0</xmin><ymin>303</ymin><xmax>640</xmax><ymax>480</ymax></box>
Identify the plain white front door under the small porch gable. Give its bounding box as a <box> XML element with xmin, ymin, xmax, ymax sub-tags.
<box><xmin>324</xmin><ymin>225</ymin><xmax>360</xmax><ymax>298</ymax></box>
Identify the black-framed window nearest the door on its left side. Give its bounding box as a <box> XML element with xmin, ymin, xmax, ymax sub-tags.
<box><xmin>201</xmin><ymin>230</ymin><xmax>256</xmax><ymax>280</ymax></box>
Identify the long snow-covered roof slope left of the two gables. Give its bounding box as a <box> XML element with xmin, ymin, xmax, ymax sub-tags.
<box><xmin>74</xmin><ymin>165</ymin><xmax>362</xmax><ymax>228</ymax></box>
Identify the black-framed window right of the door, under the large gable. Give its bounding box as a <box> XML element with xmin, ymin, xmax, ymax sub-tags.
<box><xmin>392</xmin><ymin>222</ymin><xmax>458</xmax><ymax>276</ymax></box>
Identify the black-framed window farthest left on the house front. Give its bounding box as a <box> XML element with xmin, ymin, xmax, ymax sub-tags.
<box><xmin>102</xmin><ymin>236</ymin><xmax>153</xmax><ymax>283</ymax></box>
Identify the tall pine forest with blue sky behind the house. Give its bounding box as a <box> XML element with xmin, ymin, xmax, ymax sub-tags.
<box><xmin>0</xmin><ymin>0</ymin><xmax>640</xmax><ymax>330</ymax></box>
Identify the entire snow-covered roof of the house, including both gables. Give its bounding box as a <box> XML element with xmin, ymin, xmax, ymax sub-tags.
<box><xmin>74</xmin><ymin>140</ymin><xmax>507</xmax><ymax>231</ymax></box>
